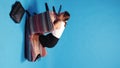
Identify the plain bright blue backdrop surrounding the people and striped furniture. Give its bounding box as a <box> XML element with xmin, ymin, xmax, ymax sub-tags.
<box><xmin>0</xmin><ymin>0</ymin><xmax>120</xmax><ymax>68</ymax></box>
